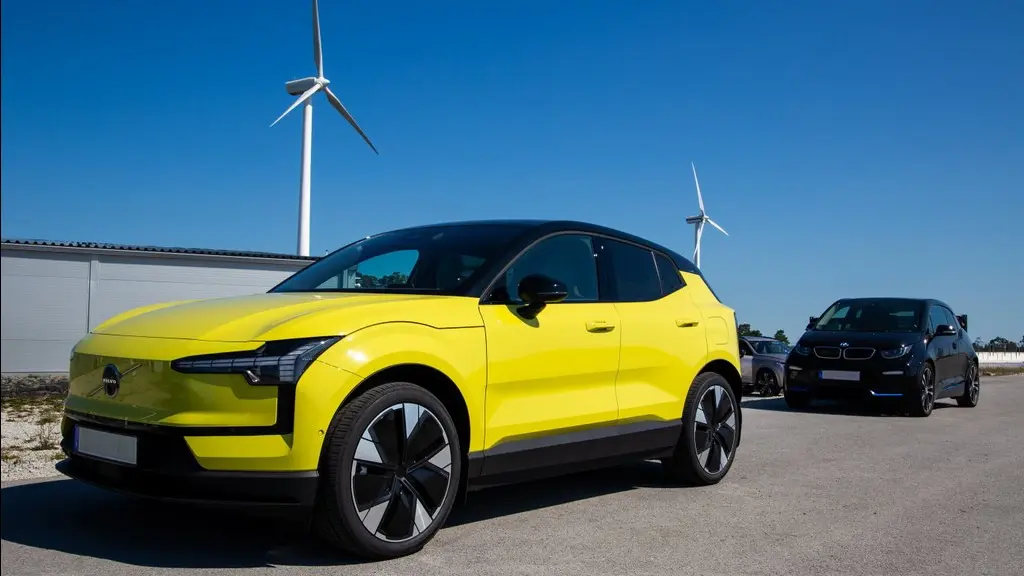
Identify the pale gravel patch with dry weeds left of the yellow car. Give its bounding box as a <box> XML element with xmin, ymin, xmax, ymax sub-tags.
<box><xmin>0</xmin><ymin>397</ymin><xmax>60</xmax><ymax>482</ymax></box>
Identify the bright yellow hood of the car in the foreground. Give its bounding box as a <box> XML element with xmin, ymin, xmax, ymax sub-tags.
<box><xmin>92</xmin><ymin>292</ymin><xmax>482</xmax><ymax>341</ymax></box>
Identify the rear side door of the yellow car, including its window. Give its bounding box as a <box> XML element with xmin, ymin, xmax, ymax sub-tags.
<box><xmin>595</xmin><ymin>238</ymin><xmax>708</xmax><ymax>422</ymax></box>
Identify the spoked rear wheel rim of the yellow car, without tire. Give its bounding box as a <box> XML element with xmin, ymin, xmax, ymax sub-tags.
<box><xmin>693</xmin><ymin>384</ymin><xmax>736</xmax><ymax>476</ymax></box>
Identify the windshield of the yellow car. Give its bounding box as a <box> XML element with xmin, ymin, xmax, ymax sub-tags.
<box><xmin>270</xmin><ymin>223</ymin><xmax>525</xmax><ymax>294</ymax></box>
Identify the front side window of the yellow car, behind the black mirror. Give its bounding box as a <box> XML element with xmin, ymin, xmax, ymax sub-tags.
<box><xmin>495</xmin><ymin>234</ymin><xmax>597</xmax><ymax>302</ymax></box>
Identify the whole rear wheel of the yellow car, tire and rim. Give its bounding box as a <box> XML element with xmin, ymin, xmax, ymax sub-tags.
<box><xmin>662</xmin><ymin>372</ymin><xmax>741</xmax><ymax>486</ymax></box>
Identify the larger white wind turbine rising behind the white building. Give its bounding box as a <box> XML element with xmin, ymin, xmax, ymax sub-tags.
<box><xmin>270</xmin><ymin>0</ymin><xmax>380</xmax><ymax>256</ymax></box>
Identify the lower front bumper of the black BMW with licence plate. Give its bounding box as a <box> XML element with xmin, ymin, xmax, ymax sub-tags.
<box><xmin>783</xmin><ymin>361</ymin><xmax>918</xmax><ymax>399</ymax></box>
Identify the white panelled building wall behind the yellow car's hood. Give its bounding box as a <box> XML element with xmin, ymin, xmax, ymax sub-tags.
<box><xmin>0</xmin><ymin>245</ymin><xmax>309</xmax><ymax>374</ymax></box>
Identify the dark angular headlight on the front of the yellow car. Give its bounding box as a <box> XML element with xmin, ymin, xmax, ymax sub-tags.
<box><xmin>171</xmin><ymin>336</ymin><xmax>342</xmax><ymax>386</ymax></box>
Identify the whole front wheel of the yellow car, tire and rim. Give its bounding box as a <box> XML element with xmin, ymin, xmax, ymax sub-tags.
<box><xmin>313</xmin><ymin>382</ymin><xmax>463</xmax><ymax>560</ymax></box>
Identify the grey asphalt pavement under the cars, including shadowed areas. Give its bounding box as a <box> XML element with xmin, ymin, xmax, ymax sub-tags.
<box><xmin>0</xmin><ymin>376</ymin><xmax>1024</xmax><ymax>576</ymax></box>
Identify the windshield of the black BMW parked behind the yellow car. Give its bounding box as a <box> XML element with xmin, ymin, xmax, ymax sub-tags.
<box><xmin>812</xmin><ymin>298</ymin><xmax>925</xmax><ymax>332</ymax></box>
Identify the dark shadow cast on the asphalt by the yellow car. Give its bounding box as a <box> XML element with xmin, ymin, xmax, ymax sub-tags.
<box><xmin>0</xmin><ymin>462</ymin><xmax>672</xmax><ymax>569</ymax></box>
